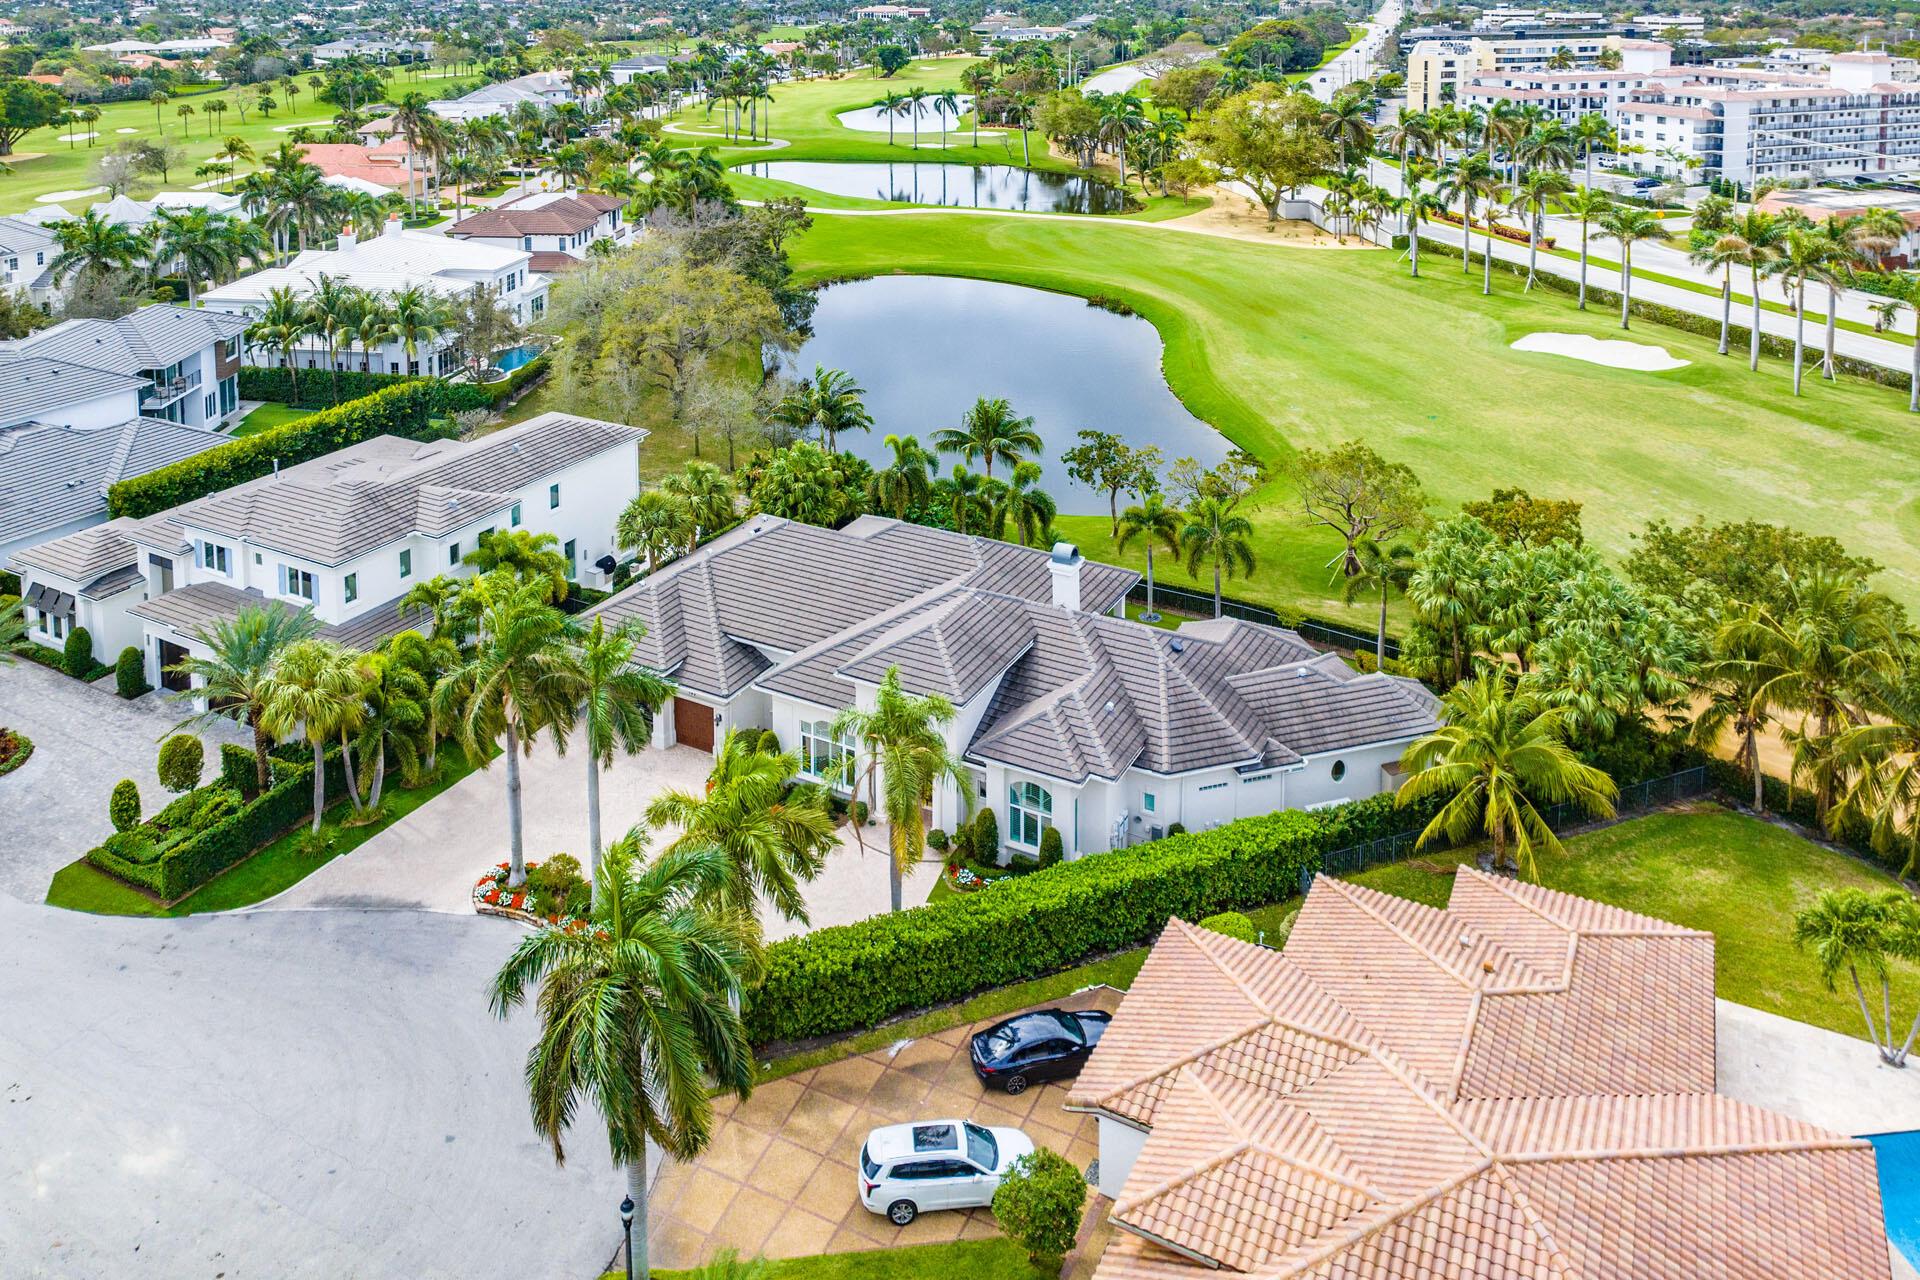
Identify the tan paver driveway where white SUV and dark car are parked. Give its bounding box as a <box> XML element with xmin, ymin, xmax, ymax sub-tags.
<box><xmin>653</xmin><ymin>986</ymin><xmax>1121</xmax><ymax>1268</ymax></box>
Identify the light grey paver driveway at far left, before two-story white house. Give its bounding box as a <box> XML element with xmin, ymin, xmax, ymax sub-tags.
<box><xmin>0</xmin><ymin>660</ymin><xmax>252</xmax><ymax>902</ymax></box>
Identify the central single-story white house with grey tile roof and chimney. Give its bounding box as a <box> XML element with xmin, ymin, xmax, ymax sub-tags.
<box><xmin>593</xmin><ymin>516</ymin><xmax>1438</xmax><ymax>858</ymax></box>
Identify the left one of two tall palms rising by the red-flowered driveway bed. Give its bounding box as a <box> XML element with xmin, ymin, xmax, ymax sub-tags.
<box><xmin>434</xmin><ymin>576</ymin><xmax>580</xmax><ymax>887</ymax></box>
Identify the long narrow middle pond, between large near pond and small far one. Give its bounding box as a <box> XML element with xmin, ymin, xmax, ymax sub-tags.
<box><xmin>735</xmin><ymin>159</ymin><xmax>1127</xmax><ymax>213</ymax></box>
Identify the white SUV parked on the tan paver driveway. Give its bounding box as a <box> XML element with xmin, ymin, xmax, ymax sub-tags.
<box><xmin>860</xmin><ymin>1121</ymin><xmax>1033</xmax><ymax>1226</ymax></box>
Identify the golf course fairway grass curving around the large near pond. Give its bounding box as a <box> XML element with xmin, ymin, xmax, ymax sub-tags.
<box><xmin>793</xmin><ymin>213</ymin><xmax>1920</xmax><ymax>631</ymax></box>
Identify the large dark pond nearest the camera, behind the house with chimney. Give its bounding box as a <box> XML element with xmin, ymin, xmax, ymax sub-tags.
<box><xmin>785</xmin><ymin>276</ymin><xmax>1231</xmax><ymax>514</ymax></box>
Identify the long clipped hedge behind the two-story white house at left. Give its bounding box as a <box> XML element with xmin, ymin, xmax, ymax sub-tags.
<box><xmin>108</xmin><ymin>378</ymin><xmax>486</xmax><ymax>518</ymax></box>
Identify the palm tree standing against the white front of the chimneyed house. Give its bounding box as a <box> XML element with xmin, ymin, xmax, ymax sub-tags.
<box><xmin>833</xmin><ymin>666</ymin><xmax>973</xmax><ymax>912</ymax></box>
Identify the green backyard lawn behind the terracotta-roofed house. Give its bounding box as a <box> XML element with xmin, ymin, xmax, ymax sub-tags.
<box><xmin>1354</xmin><ymin>804</ymin><xmax>1920</xmax><ymax>1036</ymax></box>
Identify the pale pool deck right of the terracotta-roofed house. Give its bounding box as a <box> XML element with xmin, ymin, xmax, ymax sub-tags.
<box><xmin>1715</xmin><ymin>1000</ymin><xmax>1920</xmax><ymax>1280</ymax></box>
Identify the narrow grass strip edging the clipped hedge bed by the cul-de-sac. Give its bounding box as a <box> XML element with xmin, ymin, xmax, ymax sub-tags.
<box><xmin>46</xmin><ymin>747</ymin><xmax>474</xmax><ymax>915</ymax></box>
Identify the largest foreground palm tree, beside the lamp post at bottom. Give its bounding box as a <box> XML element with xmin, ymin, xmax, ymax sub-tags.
<box><xmin>492</xmin><ymin>827</ymin><xmax>753</xmax><ymax>1280</ymax></box>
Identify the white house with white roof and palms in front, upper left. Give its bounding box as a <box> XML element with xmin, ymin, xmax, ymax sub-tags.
<box><xmin>200</xmin><ymin>217</ymin><xmax>549</xmax><ymax>374</ymax></box>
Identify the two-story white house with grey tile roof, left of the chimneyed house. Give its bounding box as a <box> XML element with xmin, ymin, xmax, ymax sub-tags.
<box><xmin>13</xmin><ymin>413</ymin><xmax>645</xmax><ymax>689</ymax></box>
